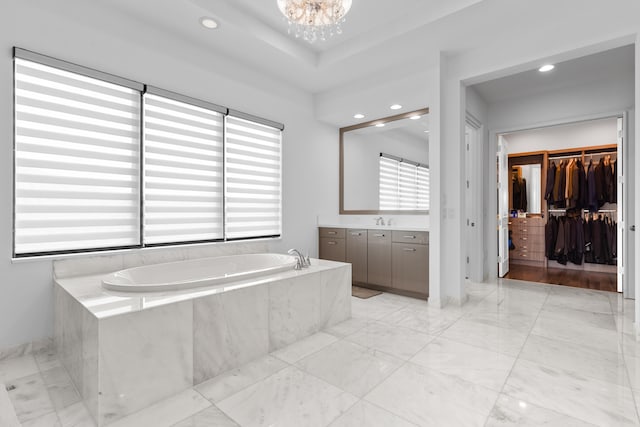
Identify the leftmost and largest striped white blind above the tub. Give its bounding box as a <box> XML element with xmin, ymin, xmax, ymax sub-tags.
<box><xmin>14</xmin><ymin>58</ymin><xmax>140</xmax><ymax>255</ymax></box>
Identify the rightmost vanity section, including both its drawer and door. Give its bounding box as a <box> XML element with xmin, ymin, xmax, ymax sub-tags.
<box><xmin>391</xmin><ymin>231</ymin><xmax>429</xmax><ymax>296</ymax></box>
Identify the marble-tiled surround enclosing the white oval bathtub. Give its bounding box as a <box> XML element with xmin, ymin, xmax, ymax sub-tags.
<box><xmin>55</xmin><ymin>260</ymin><xmax>351</xmax><ymax>426</ymax></box>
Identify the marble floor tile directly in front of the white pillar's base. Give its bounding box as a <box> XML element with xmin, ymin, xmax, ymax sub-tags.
<box><xmin>381</xmin><ymin>307</ymin><xmax>463</xmax><ymax>335</ymax></box>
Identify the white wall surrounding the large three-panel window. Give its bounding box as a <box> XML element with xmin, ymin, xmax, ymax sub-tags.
<box><xmin>0</xmin><ymin>0</ymin><xmax>338</xmax><ymax>349</ymax></box>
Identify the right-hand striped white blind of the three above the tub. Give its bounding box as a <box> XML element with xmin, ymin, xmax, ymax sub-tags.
<box><xmin>225</xmin><ymin>116</ymin><xmax>282</xmax><ymax>239</ymax></box>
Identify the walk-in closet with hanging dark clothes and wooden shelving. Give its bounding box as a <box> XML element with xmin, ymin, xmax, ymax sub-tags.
<box><xmin>501</xmin><ymin>116</ymin><xmax>623</xmax><ymax>292</ymax></box>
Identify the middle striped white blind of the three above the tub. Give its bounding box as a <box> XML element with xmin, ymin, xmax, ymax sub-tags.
<box><xmin>143</xmin><ymin>94</ymin><xmax>224</xmax><ymax>244</ymax></box>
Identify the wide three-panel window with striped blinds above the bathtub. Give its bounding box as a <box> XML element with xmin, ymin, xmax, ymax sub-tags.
<box><xmin>14</xmin><ymin>48</ymin><xmax>283</xmax><ymax>257</ymax></box>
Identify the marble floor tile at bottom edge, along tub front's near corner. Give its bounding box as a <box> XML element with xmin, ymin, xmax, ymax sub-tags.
<box><xmin>109</xmin><ymin>389</ymin><xmax>211</xmax><ymax>427</ymax></box>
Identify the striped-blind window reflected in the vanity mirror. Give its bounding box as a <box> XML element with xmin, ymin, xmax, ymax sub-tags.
<box><xmin>379</xmin><ymin>153</ymin><xmax>429</xmax><ymax>211</ymax></box>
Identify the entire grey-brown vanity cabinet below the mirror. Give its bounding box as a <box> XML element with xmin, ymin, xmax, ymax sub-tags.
<box><xmin>320</xmin><ymin>227</ymin><xmax>429</xmax><ymax>298</ymax></box>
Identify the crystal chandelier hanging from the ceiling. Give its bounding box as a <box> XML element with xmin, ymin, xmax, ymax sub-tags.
<box><xmin>278</xmin><ymin>0</ymin><xmax>352</xmax><ymax>43</ymax></box>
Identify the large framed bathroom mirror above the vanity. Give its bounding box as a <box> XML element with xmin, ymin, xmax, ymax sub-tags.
<box><xmin>340</xmin><ymin>108</ymin><xmax>429</xmax><ymax>215</ymax></box>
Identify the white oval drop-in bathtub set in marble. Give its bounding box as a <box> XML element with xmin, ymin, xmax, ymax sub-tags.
<box><xmin>102</xmin><ymin>254</ymin><xmax>296</xmax><ymax>292</ymax></box>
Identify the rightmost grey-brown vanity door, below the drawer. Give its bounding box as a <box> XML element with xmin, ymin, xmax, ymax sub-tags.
<box><xmin>392</xmin><ymin>243</ymin><xmax>429</xmax><ymax>295</ymax></box>
